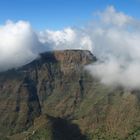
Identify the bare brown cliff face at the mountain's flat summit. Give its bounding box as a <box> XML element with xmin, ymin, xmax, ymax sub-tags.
<box><xmin>41</xmin><ymin>50</ymin><xmax>96</xmax><ymax>73</ymax></box>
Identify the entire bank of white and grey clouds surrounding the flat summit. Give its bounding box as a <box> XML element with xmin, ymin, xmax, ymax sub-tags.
<box><xmin>0</xmin><ymin>6</ymin><xmax>140</xmax><ymax>89</ymax></box>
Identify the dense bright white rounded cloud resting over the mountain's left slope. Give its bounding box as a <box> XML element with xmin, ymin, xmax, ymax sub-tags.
<box><xmin>0</xmin><ymin>21</ymin><xmax>44</xmax><ymax>71</ymax></box>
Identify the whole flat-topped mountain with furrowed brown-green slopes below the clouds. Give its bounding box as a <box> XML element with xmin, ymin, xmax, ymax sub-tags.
<box><xmin>0</xmin><ymin>50</ymin><xmax>140</xmax><ymax>140</ymax></box>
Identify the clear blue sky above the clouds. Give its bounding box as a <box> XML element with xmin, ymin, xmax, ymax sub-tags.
<box><xmin>0</xmin><ymin>0</ymin><xmax>140</xmax><ymax>30</ymax></box>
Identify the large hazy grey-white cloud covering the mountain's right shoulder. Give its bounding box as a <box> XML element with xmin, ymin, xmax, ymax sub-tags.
<box><xmin>85</xmin><ymin>6</ymin><xmax>140</xmax><ymax>89</ymax></box>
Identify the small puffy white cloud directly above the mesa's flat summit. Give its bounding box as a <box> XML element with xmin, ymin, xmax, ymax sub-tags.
<box><xmin>38</xmin><ymin>28</ymin><xmax>92</xmax><ymax>50</ymax></box>
